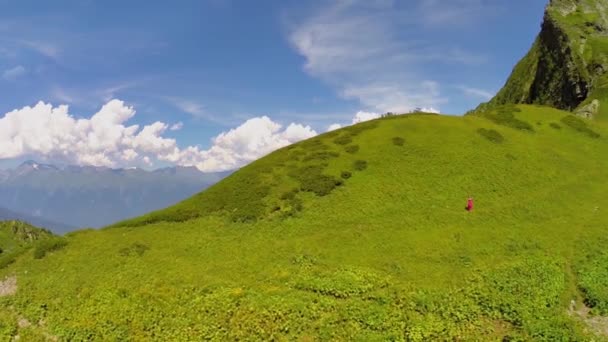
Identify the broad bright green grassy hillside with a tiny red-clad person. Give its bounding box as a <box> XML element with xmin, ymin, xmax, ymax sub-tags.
<box><xmin>0</xmin><ymin>106</ymin><xmax>608</xmax><ymax>341</ymax></box>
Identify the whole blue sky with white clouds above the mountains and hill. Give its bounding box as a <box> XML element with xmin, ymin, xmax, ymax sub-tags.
<box><xmin>0</xmin><ymin>0</ymin><xmax>545</xmax><ymax>171</ymax></box>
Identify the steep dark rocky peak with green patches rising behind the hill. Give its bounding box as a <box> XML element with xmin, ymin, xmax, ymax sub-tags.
<box><xmin>478</xmin><ymin>0</ymin><xmax>608</xmax><ymax>117</ymax></box>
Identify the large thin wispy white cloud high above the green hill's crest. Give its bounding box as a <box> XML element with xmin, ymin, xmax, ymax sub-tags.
<box><xmin>289</xmin><ymin>0</ymin><xmax>486</xmax><ymax>112</ymax></box>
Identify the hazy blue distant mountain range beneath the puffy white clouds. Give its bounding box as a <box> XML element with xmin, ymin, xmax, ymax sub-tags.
<box><xmin>0</xmin><ymin>161</ymin><xmax>230</xmax><ymax>232</ymax></box>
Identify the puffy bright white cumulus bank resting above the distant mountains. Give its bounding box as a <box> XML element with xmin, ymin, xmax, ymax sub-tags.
<box><xmin>0</xmin><ymin>100</ymin><xmax>317</xmax><ymax>172</ymax></box>
